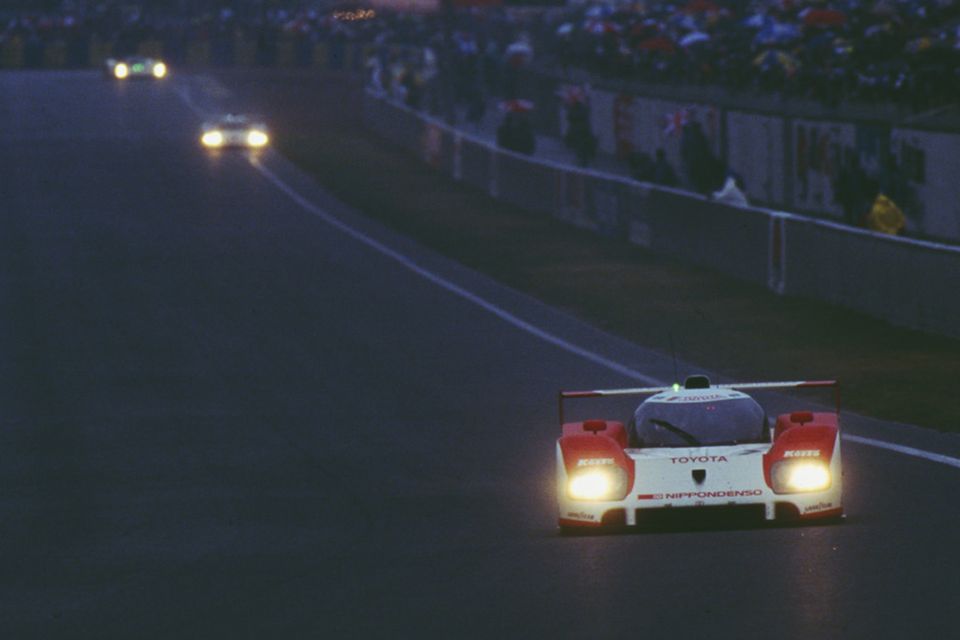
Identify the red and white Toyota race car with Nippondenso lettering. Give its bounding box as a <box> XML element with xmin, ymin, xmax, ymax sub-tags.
<box><xmin>556</xmin><ymin>376</ymin><xmax>843</xmax><ymax>531</ymax></box>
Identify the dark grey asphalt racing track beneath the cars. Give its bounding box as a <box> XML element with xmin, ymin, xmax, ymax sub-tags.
<box><xmin>0</xmin><ymin>72</ymin><xmax>960</xmax><ymax>638</ymax></box>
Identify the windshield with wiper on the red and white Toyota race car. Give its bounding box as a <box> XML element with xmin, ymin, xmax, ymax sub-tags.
<box><xmin>630</xmin><ymin>395</ymin><xmax>767</xmax><ymax>447</ymax></box>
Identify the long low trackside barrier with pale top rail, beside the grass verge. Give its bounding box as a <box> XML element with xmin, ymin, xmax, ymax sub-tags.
<box><xmin>363</xmin><ymin>92</ymin><xmax>960</xmax><ymax>337</ymax></box>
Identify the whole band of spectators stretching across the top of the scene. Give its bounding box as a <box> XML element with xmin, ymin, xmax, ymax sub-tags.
<box><xmin>0</xmin><ymin>0</ymin><xmax>960</xmax><ymax>110</ymax></box>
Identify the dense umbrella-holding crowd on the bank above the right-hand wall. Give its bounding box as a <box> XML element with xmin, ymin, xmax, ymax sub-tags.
<box><xmin>549</xmin><ymin>0</ymin><xmax>960</xmax><ymax>109</ymax></box>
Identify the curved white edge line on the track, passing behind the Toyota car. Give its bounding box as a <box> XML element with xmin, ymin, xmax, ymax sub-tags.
<box><xmin>250</xmin><ymin>152</ymin><xmax>960</xmax><ymax>469</ymax></box>
